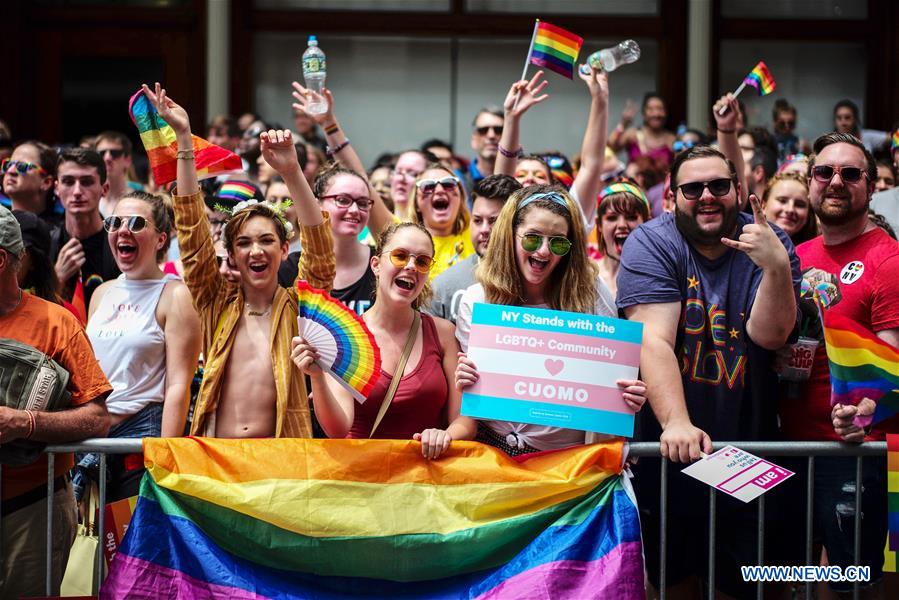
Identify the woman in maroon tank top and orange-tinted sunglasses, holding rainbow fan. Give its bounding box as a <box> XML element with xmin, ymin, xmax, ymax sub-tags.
<box><xmin>291</xmin><ymin>222</ymin><xmax>477</xmax><ymax>458</ymax></box>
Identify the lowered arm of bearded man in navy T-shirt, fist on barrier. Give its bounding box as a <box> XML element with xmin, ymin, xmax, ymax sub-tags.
<box><xmin>624</xmin><ymin>302</ymin><xmax>712</xmax><ymax>462</ymax></box>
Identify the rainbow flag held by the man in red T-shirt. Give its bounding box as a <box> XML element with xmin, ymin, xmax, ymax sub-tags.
<box><xmin>822</xmin><ymin>310</ymin><xmax>899</xmax><ymax>426</ymax></box>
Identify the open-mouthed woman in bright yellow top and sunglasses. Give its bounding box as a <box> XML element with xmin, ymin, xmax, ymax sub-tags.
<box><xmin>409</xmin><ymin>163</ymin><xmax>474</xmax><ymax>279</ymax></box>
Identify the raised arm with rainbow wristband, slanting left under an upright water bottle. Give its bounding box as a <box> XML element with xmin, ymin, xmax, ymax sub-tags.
<box><xmin>293</xmin><ymin>81</ymin><xmax>393</xmax><ymax>238</ymax></box>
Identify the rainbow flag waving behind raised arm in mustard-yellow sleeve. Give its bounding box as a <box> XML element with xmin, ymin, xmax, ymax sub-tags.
<box><xmin>128</xmin><ymin>90</ymin><xmax>243</xmax><ymax>185</ymax></box>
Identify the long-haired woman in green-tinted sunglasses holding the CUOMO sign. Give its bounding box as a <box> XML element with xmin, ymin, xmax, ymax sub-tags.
<box><xmin>455</xmin><ymin>185</ymin><xmax>646</xmax><ymax>456</ymax></box>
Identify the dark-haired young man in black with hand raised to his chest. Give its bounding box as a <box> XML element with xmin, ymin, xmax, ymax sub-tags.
<box><xmin>51</xmin><ymin>148</ymin><xmax>121</xmax><ymax>307</ymax></box>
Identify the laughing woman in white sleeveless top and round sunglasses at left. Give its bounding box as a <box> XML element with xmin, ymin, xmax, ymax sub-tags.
<box><xmin>79</xmin><ymin>191</ymin><xmax>202</xmax><ymax>500</ymax></box>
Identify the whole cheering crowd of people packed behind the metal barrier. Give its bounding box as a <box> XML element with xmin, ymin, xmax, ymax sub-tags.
<box><xmin>0</xmin><ymin>63</ymin><xmax>899</xmax><ymax>598</ymax></box>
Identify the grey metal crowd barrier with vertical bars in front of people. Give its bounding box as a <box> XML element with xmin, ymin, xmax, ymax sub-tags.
<box><xmin>0</xmin><ymin>438</ymin><xmax>887</xmax><ymax>600</ymax></box>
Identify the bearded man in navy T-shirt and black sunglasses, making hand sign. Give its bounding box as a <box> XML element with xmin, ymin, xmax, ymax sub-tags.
<box><xmin>617</xmin><ymin>144</ymin><xmax>800</xmax><ymax>598</ymax></box>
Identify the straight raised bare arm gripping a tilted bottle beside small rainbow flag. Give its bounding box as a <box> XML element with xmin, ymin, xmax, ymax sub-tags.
<box><xmin>574</xmin><ymin>67</ymin><xmax>609</xmax><ymax>224</ymax></box>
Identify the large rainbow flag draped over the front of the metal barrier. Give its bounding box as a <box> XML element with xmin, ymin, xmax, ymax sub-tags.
<box><xmin>100</xmin><ymin>438</ymin><xmax>644</xmax><ymax>599</ymax></box>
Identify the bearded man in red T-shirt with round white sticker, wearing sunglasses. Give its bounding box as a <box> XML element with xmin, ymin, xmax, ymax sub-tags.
<box><xmin>780</xmin><ymin>133</ymin><xmax>899</xmax><ymax>593</ymax></box>
